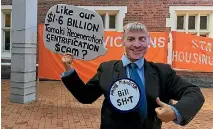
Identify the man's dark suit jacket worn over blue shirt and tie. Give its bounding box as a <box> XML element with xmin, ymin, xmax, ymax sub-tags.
<box><xmin>62</xmin><ymin>61</ymin><xmax>204</xmax><ymax>129</ymax></box>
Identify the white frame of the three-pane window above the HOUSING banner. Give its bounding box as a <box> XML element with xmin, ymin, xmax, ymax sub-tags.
<box><xmin>166</xmin><ymin>6</ymin><xmax>213</xmax><ymax>38</ymax></box>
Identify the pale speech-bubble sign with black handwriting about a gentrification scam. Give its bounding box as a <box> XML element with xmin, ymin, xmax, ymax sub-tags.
<box><xmin>44</xmin><ymin>4</ymin><xmax>106</xmax><ymax>60</ymax></box>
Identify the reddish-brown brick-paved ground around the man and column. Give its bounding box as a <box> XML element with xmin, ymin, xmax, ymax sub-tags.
<box><xmin>1</xmin><ymin>80</ymin><xmax>213</xmax><ymax>129</ymax></box>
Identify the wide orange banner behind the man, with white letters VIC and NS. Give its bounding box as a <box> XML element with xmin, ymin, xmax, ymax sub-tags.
<box><xmin>38</xmin><ymin>25</ymin><xmax>168</xmax><ymax>83</ymax></box>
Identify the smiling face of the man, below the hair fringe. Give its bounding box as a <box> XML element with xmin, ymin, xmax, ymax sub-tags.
<box><xmin>123</xmin><ymin>31</ymin><xmax>150</xmax><ymax>62</ymax></box>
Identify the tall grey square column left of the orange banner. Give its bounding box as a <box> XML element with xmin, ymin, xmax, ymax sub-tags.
<box><xmin>10</xmin><ymin>0</ymin><xmax>37</xmax><ymax>103</ymax></box>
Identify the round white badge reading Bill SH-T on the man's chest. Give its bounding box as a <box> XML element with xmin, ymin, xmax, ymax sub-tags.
<box><xmin>109</xmin><ymin>78</ymin><xmax>141</xmax><ymax>112</ymax></box>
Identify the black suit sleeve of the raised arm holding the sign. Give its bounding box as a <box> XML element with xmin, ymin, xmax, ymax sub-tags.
<box><xmin>61</xmin><ymin>62</ymin><xmax>103</xmax><ymax>104</ymax></box>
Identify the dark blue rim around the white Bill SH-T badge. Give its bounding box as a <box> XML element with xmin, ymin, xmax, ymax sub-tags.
<box><xmin>108</xmin><ymin>78</ymin><xmax>142</xmax><ymax>113</ymax></box>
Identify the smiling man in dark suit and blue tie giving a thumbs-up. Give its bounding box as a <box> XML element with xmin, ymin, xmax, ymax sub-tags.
<box><xmin>62</xmin><ymin>23</ymin><xmax>204</xmax><ymax>129</ymax></box>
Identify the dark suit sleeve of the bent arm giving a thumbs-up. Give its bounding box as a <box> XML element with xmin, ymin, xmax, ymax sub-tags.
<box><xmin>168</xmin><ymin>67</ymin><xmax>205</xmax><ymax>126</ymax></box>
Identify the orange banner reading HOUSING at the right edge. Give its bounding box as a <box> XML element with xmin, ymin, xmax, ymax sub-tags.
<box><xmin>172</xmin><ymin>32</ymin><xmax>213</xmax><ymax>72</ymax></box>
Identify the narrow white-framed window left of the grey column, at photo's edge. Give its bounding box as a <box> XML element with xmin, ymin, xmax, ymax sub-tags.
<box><xmin>1</xmin><ymin>5</ymin><xmax>12</xmax><ymax>59</ymax></box>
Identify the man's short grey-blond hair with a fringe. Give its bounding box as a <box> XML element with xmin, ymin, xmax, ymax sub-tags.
<box><xmin>123</xmin><ymin>22</ymin><xmax>148</xmax><ymax>34</ymax></box>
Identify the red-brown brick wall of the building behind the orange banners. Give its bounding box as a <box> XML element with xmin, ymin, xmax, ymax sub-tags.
<box><xmin>1</xmin><ymin>0</ymin><xmax>213</xmax><ymax>87</ymax></box>
